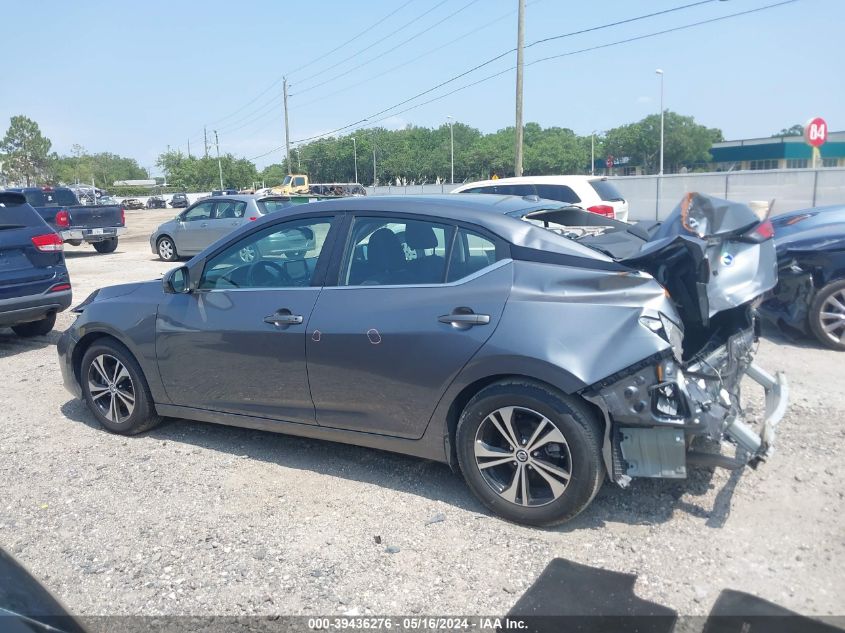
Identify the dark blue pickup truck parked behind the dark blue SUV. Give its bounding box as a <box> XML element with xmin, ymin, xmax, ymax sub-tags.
<box><xmin>7</xmin><ymin>187</ymin><xmax>126</xmax><ymax>253</ymax></box>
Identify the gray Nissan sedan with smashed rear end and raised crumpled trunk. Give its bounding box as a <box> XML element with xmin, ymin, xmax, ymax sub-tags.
<box><xmin>58</xmin><ymin>195</ymin><xmax>786</xmax><ymax>525</ymax></box>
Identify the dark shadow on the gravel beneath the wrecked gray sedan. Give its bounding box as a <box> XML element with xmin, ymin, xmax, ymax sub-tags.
<box><xmin>61</xmin><ymin>399</ymin><xmax>742</xmax><ymax>532</ymax></box>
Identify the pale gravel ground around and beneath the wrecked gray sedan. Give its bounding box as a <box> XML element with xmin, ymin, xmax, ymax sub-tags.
<box><xmin>0</xmin><ymin>210</ymin><xmax>845</xmax><ymax>615</ymax></box>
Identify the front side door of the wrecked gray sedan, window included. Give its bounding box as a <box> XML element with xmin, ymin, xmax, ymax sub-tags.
<box><xmin>156</xmin><ymin>216</ymin><xmax>337</xmax><ymax>424</ymax></box>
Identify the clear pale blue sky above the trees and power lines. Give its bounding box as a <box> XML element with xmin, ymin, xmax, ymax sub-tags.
<box><xmin>0</xmin><ymin>0</ymin><xmax>845</xmax><ymax>173</ymax></box>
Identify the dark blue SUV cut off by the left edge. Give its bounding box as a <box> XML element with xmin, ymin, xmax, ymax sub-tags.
<box><xmin>0</xmin><ymin>191</ymin><xmax>71</xmax><ymax>336</ymax></box>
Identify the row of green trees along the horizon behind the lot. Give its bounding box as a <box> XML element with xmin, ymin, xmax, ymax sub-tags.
<box><xmin>0</xmin><ymin>110</ymin><xmax>780</xmax><ymax>191</ymax></box>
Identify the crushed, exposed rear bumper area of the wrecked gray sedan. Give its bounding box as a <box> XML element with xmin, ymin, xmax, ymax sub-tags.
<box><xmin>584</xmin><ymin>330</ymin><xmax>789</xmax><ymax>486</ymax></box>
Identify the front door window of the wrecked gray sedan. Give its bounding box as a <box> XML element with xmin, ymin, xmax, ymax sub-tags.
<box><xmin>199</xmin><ymin>218</ymin><xmax>332</xmax><ymax>290</ymax></box>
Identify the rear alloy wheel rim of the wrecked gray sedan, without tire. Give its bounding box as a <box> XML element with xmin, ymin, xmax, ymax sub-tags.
<box><xmin>474</xmin><ymin>407</ymin><xmax>572</xmax><ymax>507</ymax></box>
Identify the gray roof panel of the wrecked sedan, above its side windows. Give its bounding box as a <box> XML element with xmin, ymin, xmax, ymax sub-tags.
<box><xmin>265</xmin><ymin>194</ymin><xmax>612</xmax><ymax>261</ymax></box>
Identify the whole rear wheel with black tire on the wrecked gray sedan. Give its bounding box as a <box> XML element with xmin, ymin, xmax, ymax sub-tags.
<box><xmin>455</xmin><ymin>380</ymin><xmax>605</xmax><ymax>526</ymax></box>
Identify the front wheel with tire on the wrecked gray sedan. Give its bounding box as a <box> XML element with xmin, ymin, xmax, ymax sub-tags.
<box><xmin>79</xmin><ymin>339</ymin><xmax>161</xmax><ymax>435</ymax></box>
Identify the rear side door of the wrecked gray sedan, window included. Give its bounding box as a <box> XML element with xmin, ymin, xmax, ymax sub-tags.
<box><xmin>306</xmin><ymin>216</ymin><xmax>513</xmax><ymax>438</ymax></box>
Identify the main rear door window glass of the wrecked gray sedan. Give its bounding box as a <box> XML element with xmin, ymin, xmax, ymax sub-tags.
<box><xmin>341</xmin><ymin>217</ymin><xmax>454</xmax><ymax>286</ymax></box>
